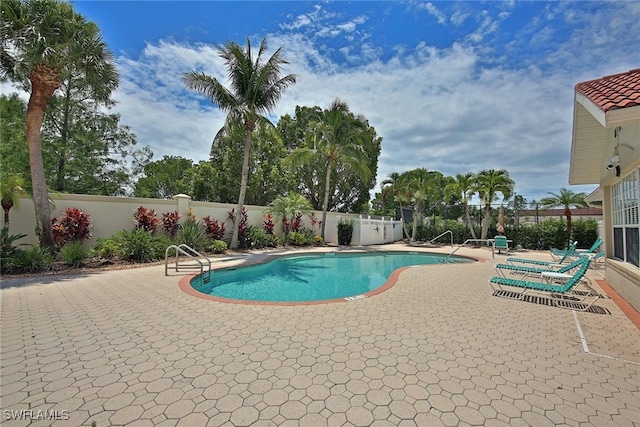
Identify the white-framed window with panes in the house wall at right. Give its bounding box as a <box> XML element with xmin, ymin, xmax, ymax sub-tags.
<box><xmin>611</xmin><ymin>169</ymin><xmax>640</xmax><ymax>267</ymax></box>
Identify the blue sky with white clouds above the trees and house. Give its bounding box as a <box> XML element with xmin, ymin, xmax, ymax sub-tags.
<box><xmin>66</xmin><ymin>1</ymin><xmax>640</xmax><ymax>201</ymax></box>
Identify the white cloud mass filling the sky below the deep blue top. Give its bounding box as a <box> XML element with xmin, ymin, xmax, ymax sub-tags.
<box><xmin>94</xmin><ymin>0</ymin><xmax>638</xmax><ymax>204</ymax></box>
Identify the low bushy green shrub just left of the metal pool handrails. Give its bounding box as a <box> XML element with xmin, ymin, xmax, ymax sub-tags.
<box><xmin>115</xmin><ymin>228</ymin><xmax>171</xmax><ymax>262</ymax></box>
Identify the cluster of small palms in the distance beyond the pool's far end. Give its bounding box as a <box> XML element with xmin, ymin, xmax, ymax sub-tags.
<box><xmin>381</xmin><ymin>168</ymin><xmax>515</xmax><ymax>241</ymax></box>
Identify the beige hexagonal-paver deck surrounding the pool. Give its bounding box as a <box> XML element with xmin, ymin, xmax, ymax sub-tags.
<box><xmin>0</xmin><ymin>244</ymin><xmax>640</xmax><ymax>427</ymax></box>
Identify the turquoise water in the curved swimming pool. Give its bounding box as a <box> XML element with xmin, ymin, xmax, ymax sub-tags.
<box><xmin>191</xmin><ymin>252</ymin><xmax>469</xmax><ymax>302</ymax></box>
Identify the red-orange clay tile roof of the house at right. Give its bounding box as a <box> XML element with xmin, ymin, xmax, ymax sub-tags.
<box><xmin>576</xmin><ymin>68</ymin><xmax>640</xmax><ymax>112</ymax></box>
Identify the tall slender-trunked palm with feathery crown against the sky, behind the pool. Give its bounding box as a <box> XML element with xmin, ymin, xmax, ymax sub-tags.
<box><xmin>183</xmin><ymin>38</ymin><xmax>296</xmax><ymax>249</ymax></box>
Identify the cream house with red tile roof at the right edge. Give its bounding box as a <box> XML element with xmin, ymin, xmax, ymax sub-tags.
<box><xmin>569</xmin><ymin>69</ymin><xmax>640</xmax><ymax>311</ymax></box>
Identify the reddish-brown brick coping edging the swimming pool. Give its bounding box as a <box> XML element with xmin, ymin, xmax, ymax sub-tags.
<box><xmin>178</xmin><ymin>250</ymin><xmax>484</xmax><ymax>306</ymax></box>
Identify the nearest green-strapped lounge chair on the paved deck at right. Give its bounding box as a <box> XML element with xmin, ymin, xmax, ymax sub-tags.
<box><xmin>489</xmin><ymin>257</ymin><xmax>600</xmax><ymax>311</ymax></box>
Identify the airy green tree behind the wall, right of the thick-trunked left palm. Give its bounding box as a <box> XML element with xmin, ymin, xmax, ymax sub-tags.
<box><xmin>42</xmin><ymin>84</ymin><xmax>153</xmax><ymax>196</ymax></box>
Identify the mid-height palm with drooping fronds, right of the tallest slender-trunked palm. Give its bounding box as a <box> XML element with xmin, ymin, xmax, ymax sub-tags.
<box><xmin>285</xmin><ymin>99</ymin><xmax>371</xmax><ymax>239</ymax></box>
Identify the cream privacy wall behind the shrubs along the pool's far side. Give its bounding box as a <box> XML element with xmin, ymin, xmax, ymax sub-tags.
<box><xmin>2</xmin><ymin>194</ymin><xmax>402</xmax><ymax>245</ymax></box>
